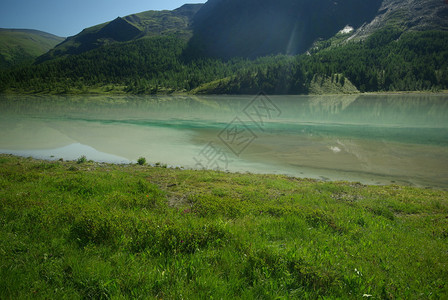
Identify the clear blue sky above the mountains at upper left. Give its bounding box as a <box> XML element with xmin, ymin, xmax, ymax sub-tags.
<box><xmin>0</xmin><ymin>0</ymin><xmax>206</xmax><ymax>37</ymax></box>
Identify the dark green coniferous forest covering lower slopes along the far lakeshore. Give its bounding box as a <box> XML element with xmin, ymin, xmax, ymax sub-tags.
<box><xmin>0</xmin><ymin>27</ymin><xmax>448</xmax><ymax>94</ymax></box>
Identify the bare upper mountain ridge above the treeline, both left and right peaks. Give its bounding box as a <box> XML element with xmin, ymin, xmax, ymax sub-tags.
<box><xmin>33</xmin><ymin>0</ymin><xmax>448</xmax><ymax>63</ymax></box>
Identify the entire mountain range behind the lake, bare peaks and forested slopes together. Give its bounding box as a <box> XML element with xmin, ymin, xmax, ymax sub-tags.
<box><xmin>0</xmin><ymin>0</ymin><xmax>448</xmax><ymax>94</ymax></box>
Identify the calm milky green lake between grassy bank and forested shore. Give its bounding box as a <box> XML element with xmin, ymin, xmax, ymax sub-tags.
<box><xmin>0</xmin><ymin>94</ymin><xmax>448</xmax><ymax>189</ymax></box>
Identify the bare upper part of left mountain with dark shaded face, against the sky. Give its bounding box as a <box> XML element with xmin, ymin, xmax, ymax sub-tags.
<box><xmin>38</xmin><ymin>4</ymin><xmax>202</xmax><ymax>62</ymax></box>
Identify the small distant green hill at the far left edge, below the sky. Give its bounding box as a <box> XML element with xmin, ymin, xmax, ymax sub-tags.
<box><xmin>0</xmin><ymin>28</ymin><xmax>64</xmax><ymax>69</ymax></box>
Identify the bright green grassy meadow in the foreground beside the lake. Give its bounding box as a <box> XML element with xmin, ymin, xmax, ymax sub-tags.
<box><xmin>0</xmin><ymin>155</ymin><xmax>448</xmax><ymax>299</ymax></box>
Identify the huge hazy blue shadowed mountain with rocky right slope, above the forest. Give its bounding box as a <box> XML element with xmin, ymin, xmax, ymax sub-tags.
<box><xmin>190</xmin><ymin>0</ymin><xmax>448</xmax><ymax>59</ymax></box>
